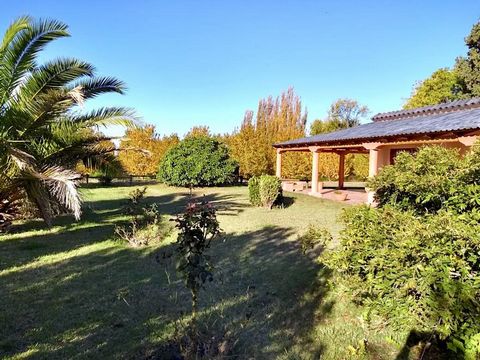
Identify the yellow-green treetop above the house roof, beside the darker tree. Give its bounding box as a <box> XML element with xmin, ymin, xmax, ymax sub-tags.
<box><xmin>403</xmin><ymin>68</ymin><xmax>464</xmax><ymax>109</ymax></box>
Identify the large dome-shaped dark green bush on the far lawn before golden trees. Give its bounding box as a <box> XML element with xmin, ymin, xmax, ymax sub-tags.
<box><xmin>158</xmin><ymin>136</ymin><xmax>238</xmax><ymax>189</ymax></box>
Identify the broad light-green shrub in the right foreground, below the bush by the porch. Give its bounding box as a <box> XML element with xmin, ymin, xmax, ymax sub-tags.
<box><xmin>323</xmin><ymin>206</ymin><xmax>480</xmax><ymax>356</ymax></box>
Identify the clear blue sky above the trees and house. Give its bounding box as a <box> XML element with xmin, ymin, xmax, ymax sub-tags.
<box><xmin>0</xmin><ymin>0</ymin><xmax>480</xmax><ymax>135</ymax></box>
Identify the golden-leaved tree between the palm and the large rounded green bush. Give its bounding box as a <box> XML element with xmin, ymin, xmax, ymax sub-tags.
<box><xmin>118</xmin><ymin>125</ymin><xmax>180</xmax><ymax>175</ymax></box>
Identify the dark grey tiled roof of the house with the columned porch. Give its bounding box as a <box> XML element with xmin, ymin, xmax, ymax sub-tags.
<box><xmin>274</xmin><ymin>98</ymin><xmax>480</xmax><ymax>147</ymax></box>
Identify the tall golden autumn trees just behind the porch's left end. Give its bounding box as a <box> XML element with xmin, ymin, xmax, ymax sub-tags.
<box><xmin>229</xmin><ymin>88</ymin><xmax>311</xmax><ymax>178</ymax></box>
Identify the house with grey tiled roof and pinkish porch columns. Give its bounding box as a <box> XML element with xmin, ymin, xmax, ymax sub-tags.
<box><xmin>273</xmin><ymin>98</ymin><xmax>480</xmax><ymax>203</ymax></box>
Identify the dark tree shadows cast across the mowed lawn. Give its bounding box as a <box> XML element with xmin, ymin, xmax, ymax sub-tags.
<box><xmin>0</xmin><ymin>188</ymin><xmax>333</xmax><ymax>359</ymax></box>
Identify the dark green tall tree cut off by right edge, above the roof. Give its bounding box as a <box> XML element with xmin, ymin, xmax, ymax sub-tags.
<box><xmin>455</xmin><ymin>22</ymin><xmax>480</xmax><ymax>97</ymax></box>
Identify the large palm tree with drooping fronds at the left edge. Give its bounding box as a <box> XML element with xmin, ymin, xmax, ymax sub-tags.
<box><xmin>0</xmin><ymin>17</ymin><xmax>136</xmax><ymax>228</ymax></box>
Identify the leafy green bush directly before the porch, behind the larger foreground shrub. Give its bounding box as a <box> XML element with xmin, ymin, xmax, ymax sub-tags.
<box><xmin>369</xmin><ymin>146</ymin><xmax>480</xmax><ymax>214</ymax></box>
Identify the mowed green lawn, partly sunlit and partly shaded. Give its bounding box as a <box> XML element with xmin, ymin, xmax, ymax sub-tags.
<box><xmin>0</xmin><ymin>184</ymin><xmax>405</xmax><ymax>359</ymax></box>
